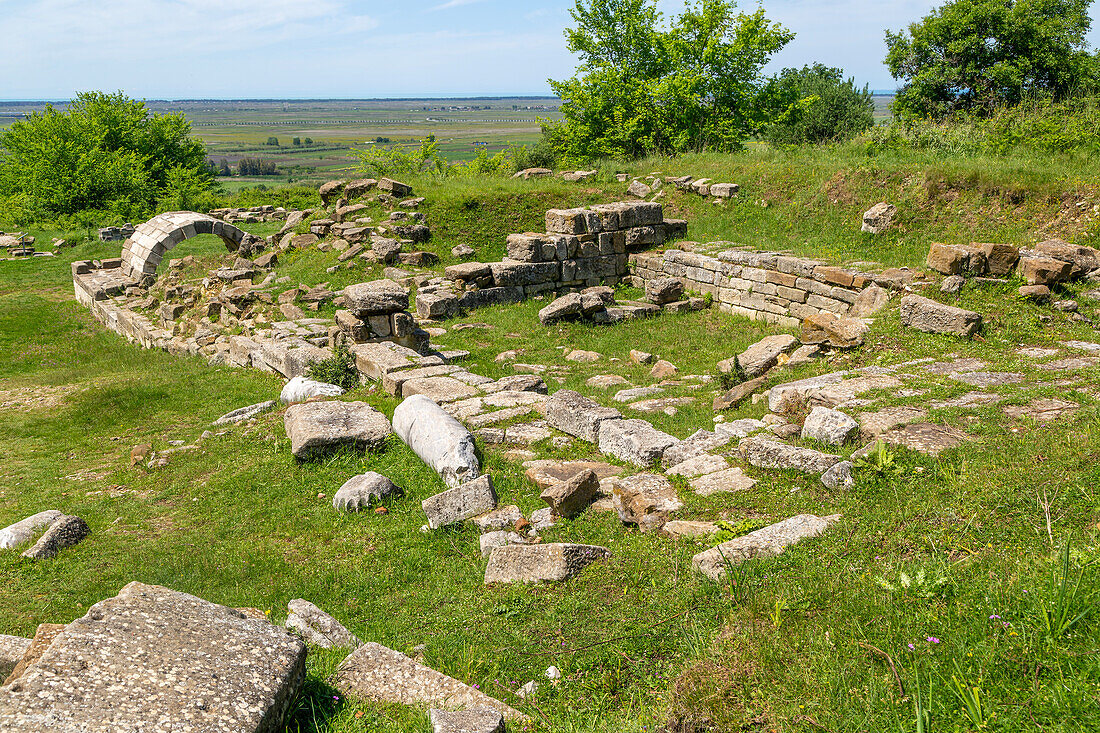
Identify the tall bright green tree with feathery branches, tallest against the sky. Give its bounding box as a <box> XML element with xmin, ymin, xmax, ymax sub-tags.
<box><xmin>543</xmin><ymin>0</ymin><xmax>793</xmax><ymax>161</ymax></box>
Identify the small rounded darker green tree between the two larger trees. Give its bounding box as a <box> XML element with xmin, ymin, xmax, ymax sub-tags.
<box><xmin>767</xmin><ymin>64</ymin><xmax>875</xmax><ymax>145</ymax></box>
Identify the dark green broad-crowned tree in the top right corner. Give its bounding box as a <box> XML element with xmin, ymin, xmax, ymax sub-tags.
<box><xmin>886</xmin><ymin>0</ymin><xmax>1098</xmax><ymax>118</ymax></box>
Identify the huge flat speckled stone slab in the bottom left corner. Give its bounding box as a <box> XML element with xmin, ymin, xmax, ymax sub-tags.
<box><xmin>0</xmin><ymin>582</ymin><xmax>306</xmax><ymax>733</ymax></box>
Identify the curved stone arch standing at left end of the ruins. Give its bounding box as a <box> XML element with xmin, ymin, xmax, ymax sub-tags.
<box><xmin>122</xmin><ymin>211</ymin><xmax>249</xmax><ymax>280</ymax></box>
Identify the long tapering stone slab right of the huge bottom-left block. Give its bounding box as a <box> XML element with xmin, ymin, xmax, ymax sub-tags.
<box><xmin>332</xmin><ymin>642</ymin><xmax>527</xmax><ymax>722</ymax></box>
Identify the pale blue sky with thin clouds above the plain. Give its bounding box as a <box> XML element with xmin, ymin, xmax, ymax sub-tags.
<box><xmin>0</xmin><ymin>0</ymin><xmax>1100</xmax><ymax>99</ymax></box>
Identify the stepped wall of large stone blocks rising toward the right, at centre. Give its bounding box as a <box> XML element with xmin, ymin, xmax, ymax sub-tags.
<box><xmin>416</xmin><ymin>201</ymin><xmax>688</xmax><ymax>318</ymax></box>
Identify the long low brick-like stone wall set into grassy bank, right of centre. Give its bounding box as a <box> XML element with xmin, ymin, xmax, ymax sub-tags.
<box><xmin>630</xmin><ymin>249</ymin><xmax>904</xmax><ymax>328</ymax></box>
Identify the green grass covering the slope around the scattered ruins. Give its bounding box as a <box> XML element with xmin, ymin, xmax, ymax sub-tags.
<box><xmin>0</xmin><ymin>144</ymin><xmax>1100</xmax><ymax>731</ymax></box>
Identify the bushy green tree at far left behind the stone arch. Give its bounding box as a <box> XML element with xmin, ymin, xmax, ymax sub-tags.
<box><xmin>0</xmin><ymin>91</ymin><xmax>209</xmax><ymax>220</ymax></box>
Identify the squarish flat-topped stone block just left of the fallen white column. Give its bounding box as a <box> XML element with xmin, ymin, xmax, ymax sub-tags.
<box><xmin>283</xmin><ymin>402</ymin><xmax>393</xmax><ymax>459</ymax></box>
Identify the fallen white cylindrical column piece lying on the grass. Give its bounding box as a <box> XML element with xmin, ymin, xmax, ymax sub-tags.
<box><xmin>394</xmin><ymin>395</ymin><xmax>481</xmax><ymax>488</ymax></box>
